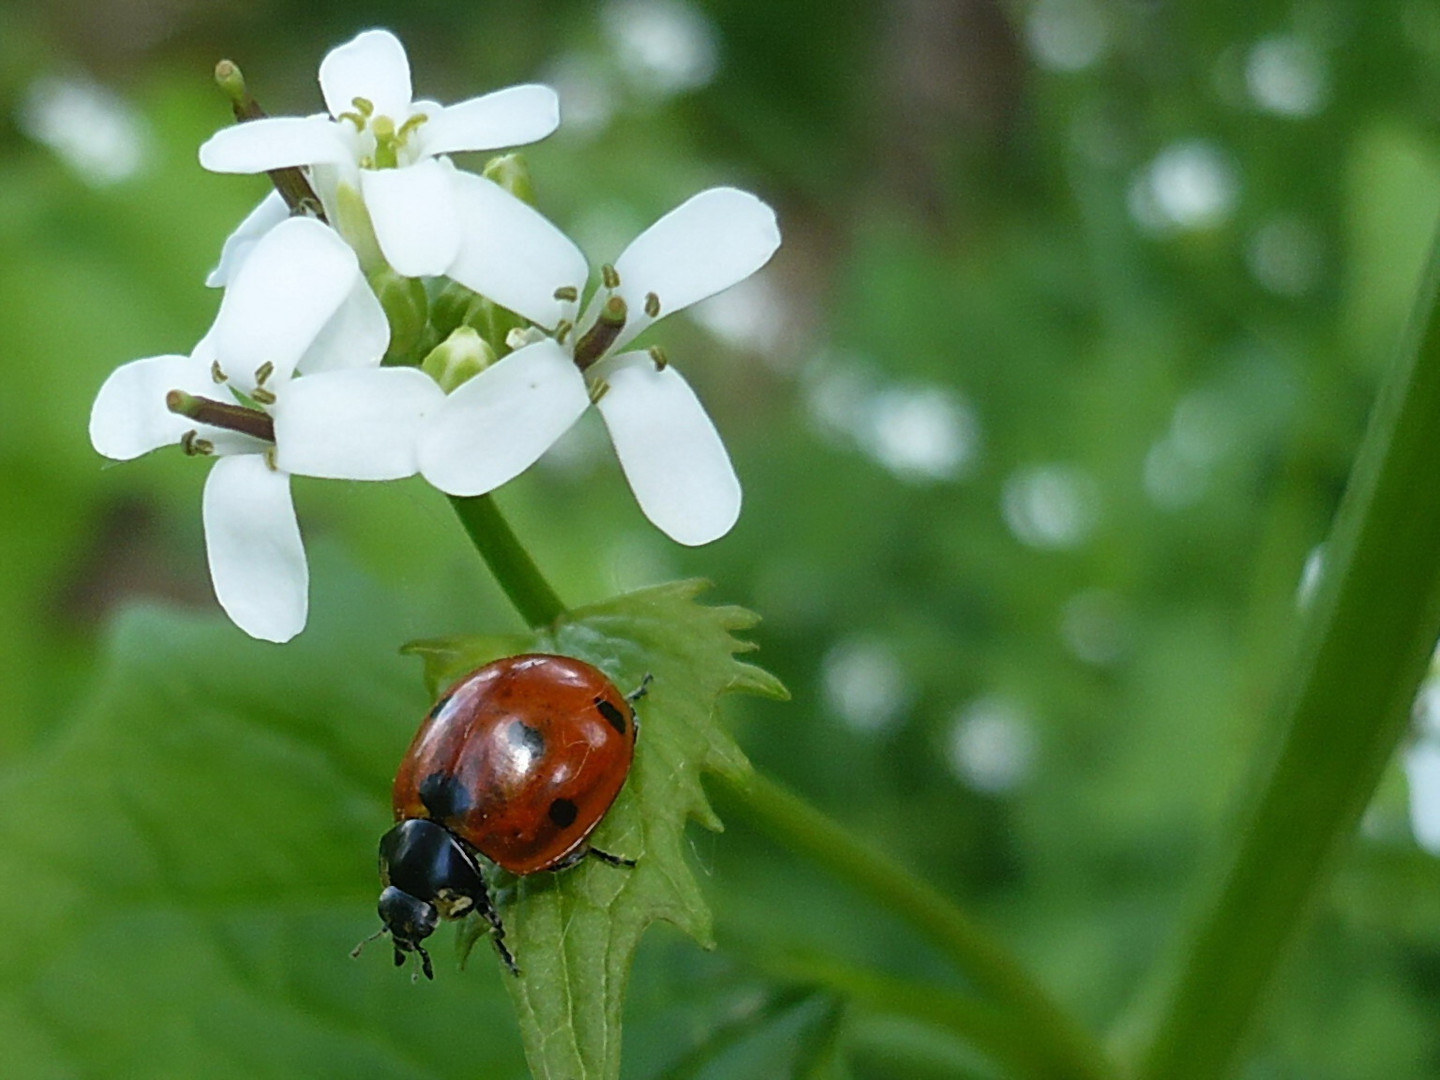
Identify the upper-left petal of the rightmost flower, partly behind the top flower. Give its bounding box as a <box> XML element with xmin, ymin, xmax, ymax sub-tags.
<box><xmin>446</xmin><ymin>171</ymin><xmax>590</xmax><ymax>328</ymax></box>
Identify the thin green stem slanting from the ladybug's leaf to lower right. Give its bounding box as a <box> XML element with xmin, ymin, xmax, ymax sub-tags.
<box><xmin>716</xmin><ymin>772</ymin><xmax>1113</xmax><ymax>1080</ymax></box>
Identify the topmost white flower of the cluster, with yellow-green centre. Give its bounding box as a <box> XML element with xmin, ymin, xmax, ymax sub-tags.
<box><xmin>200</xmin><ymin>30</ymin><xmax>560</xmax><ymax>282</ymax></box>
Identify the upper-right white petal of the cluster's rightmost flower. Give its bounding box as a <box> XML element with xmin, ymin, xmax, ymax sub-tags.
<box><xmin>613</xmin><ymin>187</ymin><xmax>780</xmax><ymax>348</ymax></box>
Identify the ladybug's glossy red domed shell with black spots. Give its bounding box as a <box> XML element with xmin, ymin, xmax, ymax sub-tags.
<box><xmin>393</xmin><ymin>654</ymin><xmax>635</xmax><ymax>874</ymax></box>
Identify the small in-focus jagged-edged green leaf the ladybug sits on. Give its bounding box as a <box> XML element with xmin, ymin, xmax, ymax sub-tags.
<box><xmin>409</xmin><ymin>580</ymin><xmax>786</xmax><ymax>1080</ymax></box>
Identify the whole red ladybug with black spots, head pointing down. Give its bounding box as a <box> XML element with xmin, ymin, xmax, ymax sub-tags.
<box><xmin>365</xmin><ymin>654</ymin><xmax>649</xmax><ymax>979</ymax></box>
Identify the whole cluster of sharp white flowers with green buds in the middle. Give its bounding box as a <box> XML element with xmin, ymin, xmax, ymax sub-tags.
<box><xmin>89</xmin><ymin>30</ymin><xmax>779</xmax><ymax>641</ymax></box>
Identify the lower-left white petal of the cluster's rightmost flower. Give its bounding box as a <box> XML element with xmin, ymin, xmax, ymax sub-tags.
<box><xmin>420</xmin><ymin>338</ymin><xmax>590</xmax><ymax>495</ymax></box>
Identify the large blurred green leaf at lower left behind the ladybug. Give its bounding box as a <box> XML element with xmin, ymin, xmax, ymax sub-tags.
<box><xmin>0</xmin><ymin>582</ymin><xmax>524</xmax><ymax>1080</ymax></box>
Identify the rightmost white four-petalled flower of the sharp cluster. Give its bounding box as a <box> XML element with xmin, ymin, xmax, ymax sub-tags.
<box><xmin>420</xmin><ymin>182</ymin><xmax>780</xmax><ymax>544</ymax></box>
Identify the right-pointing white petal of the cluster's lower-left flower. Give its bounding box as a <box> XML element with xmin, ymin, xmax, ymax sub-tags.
<box><xmin>275</xmin><ymin>367</ymin><xmax>445</xmax><ymax>480</ymax></box>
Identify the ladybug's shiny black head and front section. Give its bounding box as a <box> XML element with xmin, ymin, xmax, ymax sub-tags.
<box><xmin>365</xmin><ymin>818</ymin><xmax>490</xmax><ymax>979</ymax></box>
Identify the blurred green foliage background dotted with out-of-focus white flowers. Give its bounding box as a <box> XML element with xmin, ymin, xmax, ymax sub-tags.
<box><xmin>0</xmin><ymin>0</ymin><xmax>1440</xmax><ymax>1080</ymax></box>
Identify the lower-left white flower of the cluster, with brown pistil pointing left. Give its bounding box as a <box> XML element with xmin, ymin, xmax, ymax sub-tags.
<box><xmin>89</xmin><ymin>217</ymin><xmax>444</xmax><ymax>641</ymax></box>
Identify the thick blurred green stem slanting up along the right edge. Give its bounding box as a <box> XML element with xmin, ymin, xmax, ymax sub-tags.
<box><xmin>1139</xmin><ymin>217</ymin><xmax>1440</xmax><ymax>1080</ymax></box>
